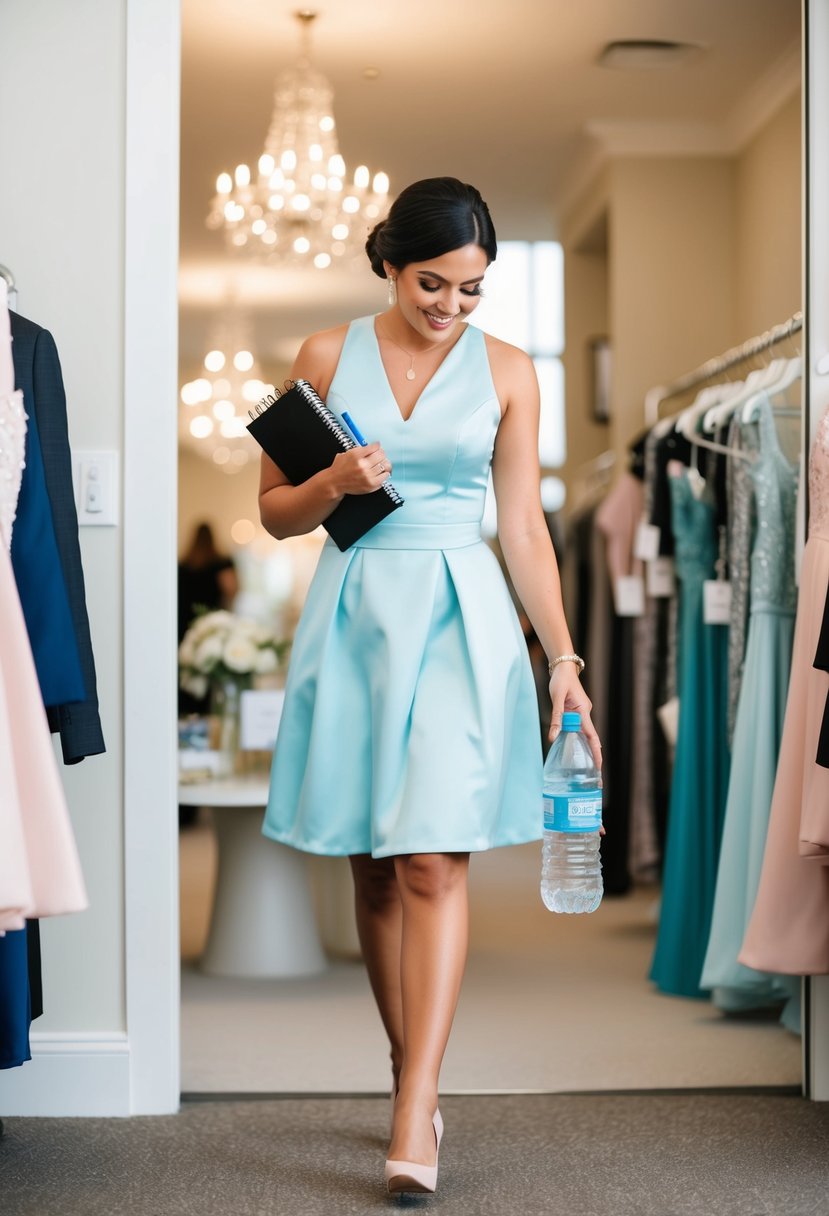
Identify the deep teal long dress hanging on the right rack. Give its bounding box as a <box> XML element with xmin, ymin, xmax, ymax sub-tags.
<box><xmin>650</xmin><ymin>473</ymin><xmax>728</xmax><ymax>997</ymax></box>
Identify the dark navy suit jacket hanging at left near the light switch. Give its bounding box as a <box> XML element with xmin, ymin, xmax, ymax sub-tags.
<box><xmin>10</xmin><ymin>313</ymin><xmax>106</xmax><ymax>764</ymax></box>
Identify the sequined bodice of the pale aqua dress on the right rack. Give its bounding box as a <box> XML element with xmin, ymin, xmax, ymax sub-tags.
<box><xmin>746</xmin><ymin>396</ymin><xmax>797</xmax><ymax>614</ymax></box>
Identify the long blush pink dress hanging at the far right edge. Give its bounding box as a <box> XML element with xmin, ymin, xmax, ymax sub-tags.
<box><xmin>739</xmin><ymin>411</ymin><xmax>829</xmax><ymax>975</ymax></box>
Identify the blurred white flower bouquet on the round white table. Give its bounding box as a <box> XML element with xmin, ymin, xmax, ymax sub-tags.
<box><xmin>179</xmin><ymin>610</ymin><xmax>289</xmax><ymax>697</ymax></box>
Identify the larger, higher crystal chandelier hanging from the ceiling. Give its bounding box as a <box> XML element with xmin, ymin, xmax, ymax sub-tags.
<box><xmin>207</xmin><ymin>10</ymin><xmax>389</xmax><ymax>270</ymax></box>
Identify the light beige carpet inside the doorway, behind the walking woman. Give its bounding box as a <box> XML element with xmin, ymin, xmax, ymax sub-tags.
<box><xmin>181</xmin><ymin>827</ymin><xmax>801</xmax><ymax>1093</ymax></box>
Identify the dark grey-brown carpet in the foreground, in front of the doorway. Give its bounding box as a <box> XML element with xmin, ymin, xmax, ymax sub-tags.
<box><xmin>6</xmin><ymin>1094</ymin><xmax>829</xmax><ymax>1216</ymax></box>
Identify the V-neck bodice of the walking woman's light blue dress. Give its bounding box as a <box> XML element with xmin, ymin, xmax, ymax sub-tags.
<box><xmin>327</xmin><ymin>316</ymin><xmax>501</xmax><ymax>542</ymax></box>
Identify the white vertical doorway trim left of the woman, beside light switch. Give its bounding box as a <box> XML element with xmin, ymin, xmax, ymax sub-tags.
<box><xmin>124</xmin><ymin>0</ymin><xmax>181</xmax><ymax>1114</ymax></box>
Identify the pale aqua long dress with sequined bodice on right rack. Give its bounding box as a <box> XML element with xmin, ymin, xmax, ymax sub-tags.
<box><xmin>700</xmin><ymin>399</ymin><xmax>800</xmax><ymax>1029</ymax></box>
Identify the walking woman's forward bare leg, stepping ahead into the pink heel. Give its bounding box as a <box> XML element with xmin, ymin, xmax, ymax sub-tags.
<box><xmin>389</xmin><ymin>852</ymin><xmax>469</xmax><ymax>1165</ymax></box>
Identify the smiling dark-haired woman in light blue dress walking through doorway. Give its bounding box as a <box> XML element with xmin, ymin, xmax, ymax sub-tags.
<box><xmin>260</xmin><ymin>178</ymin><xmax>599</xmax><ymax>1193</ymax></box>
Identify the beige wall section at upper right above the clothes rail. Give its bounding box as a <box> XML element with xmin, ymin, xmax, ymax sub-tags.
<box><xmin>734</xmin><ymin>90</ymin><xmax>802</xmax><ymax>340</ymax></box>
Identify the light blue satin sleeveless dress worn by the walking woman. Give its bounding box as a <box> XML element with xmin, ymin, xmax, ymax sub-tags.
<box><xmin>263</xmin><ymin>316</ymin><xmax>542</xmax><ymax>857</ymax></box>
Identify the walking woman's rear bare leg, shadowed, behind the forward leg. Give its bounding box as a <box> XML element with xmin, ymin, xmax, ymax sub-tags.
<box><xmin>349</xmin><ymin>854</ymin><xmax>404</xmax><ymax>1083</ymax></box>
